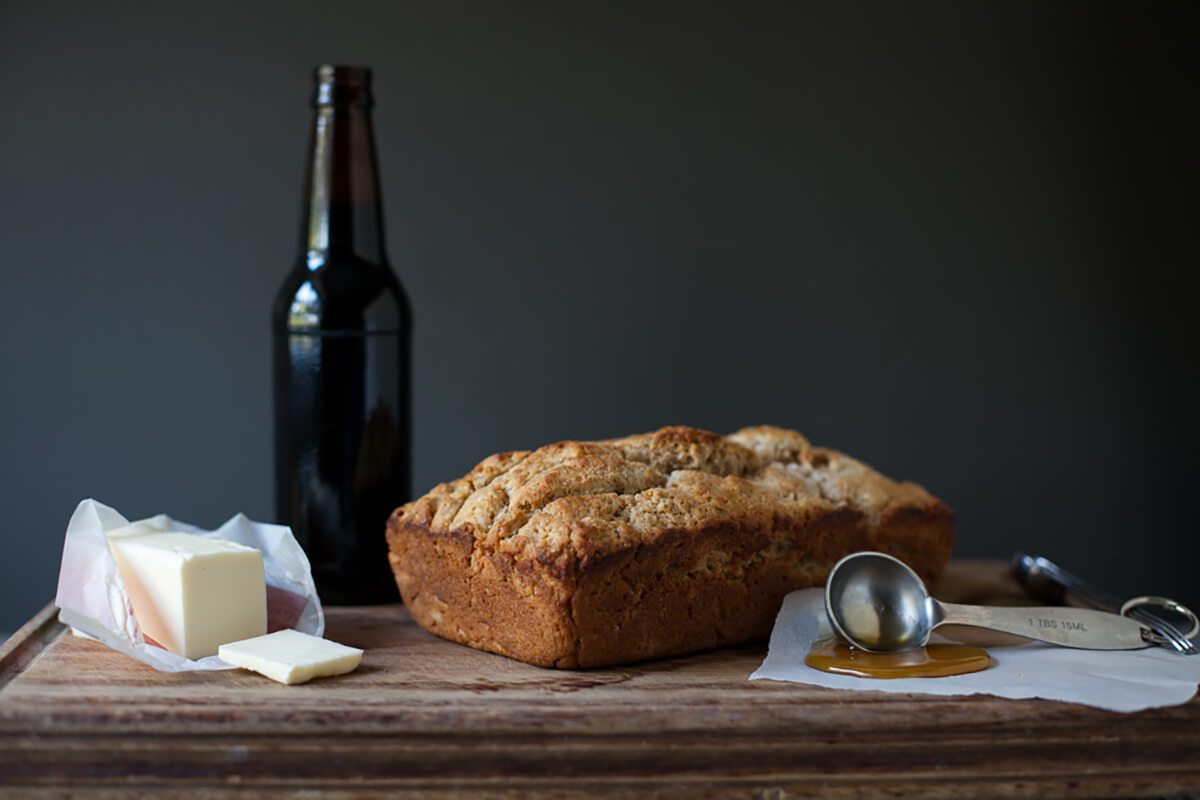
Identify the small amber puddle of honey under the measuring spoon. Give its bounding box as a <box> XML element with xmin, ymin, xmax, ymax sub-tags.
<box><xmin>804</xmin><ymin>637</ymin><xmax>991</xmax><ymax>678</ymax></box>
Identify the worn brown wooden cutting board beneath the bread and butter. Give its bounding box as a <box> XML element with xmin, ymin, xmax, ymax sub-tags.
<box><xmin>0</xmin><ymin>561</ymin><xmax>1200</xmax><ymax>799</ymax></box>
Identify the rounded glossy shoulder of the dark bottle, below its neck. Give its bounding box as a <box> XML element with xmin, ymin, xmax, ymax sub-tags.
<box><xmin>274</xmin><ymin>257</ymin><xmax>412</xmax><ymax>332</ymax></box>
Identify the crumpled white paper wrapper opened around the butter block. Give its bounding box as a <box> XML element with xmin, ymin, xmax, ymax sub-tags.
<box><xmin>54</xmin><ymin>500</ymin><xmax>325</xmax><ymax>672</ymax></box>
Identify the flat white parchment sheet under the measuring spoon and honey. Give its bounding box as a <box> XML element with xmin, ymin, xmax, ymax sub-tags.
<box><xmin>750</xmin><ymin>589</ymin><xmax>1200</xmax><ymax>711</ymax></box>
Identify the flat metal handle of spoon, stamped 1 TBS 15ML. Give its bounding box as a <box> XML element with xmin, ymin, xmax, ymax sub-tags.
<box><xmin>934</xmin><ymin>602</ymin><xmax>1152</xmax><ymax>650</ymax></box>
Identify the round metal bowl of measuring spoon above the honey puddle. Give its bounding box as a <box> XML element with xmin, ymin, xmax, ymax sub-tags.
<box><xmin>826</xmin><ymin>552</ymin><xmax>941</xmax><ymax>652</ymax></box>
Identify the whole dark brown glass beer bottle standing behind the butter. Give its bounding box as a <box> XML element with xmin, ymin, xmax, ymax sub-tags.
<box><xmin>272</xmin><ymin>66</ymin><xmax>412</xmax><ymax>604</ymax></box>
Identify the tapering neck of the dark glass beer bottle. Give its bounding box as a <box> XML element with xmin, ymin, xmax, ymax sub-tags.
<box><xmin>301</xmin><ymin>73</ymin><xmax>386</xmax><ymax>270</ymax></box>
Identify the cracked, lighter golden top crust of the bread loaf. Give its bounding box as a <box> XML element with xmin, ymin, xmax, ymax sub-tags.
<box><xmin>392</xmin><ymin>426</ymin><xmax>949</xmax><ymax>565</ymax></box>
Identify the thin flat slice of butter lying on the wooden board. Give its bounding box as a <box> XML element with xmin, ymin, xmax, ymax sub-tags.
<box><xmin>217</xmin><ymin>631</ymin><xmax>362</xmax><ymax>685</ymax></box>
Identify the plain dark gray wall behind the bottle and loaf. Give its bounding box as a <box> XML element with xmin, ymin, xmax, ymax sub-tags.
<box><xmin>0</xmin><ymin>0</ymin><xmax>1200</xmax><ymax>630</ymax></box>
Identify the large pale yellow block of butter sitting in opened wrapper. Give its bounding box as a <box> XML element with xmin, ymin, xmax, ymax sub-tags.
<box><xmin>108</xmin><ymin>525</ymin><xmax>266</xmax><ymax>658</ymax></box>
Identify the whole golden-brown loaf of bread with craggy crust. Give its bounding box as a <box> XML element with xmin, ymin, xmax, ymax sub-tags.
<box><xmin>388</xmin><ymin>427</ymin><xmax>954</xmax><ymax>668</ymax></box>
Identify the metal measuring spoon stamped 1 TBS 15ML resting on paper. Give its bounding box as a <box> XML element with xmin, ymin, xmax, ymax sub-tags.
<box><xmin>826</xmin><ymin>552</ymin><xmax>1152</xmax><ymax>652</ymax></box>
